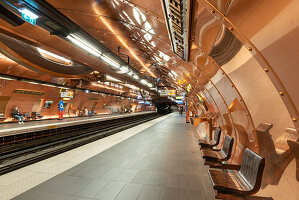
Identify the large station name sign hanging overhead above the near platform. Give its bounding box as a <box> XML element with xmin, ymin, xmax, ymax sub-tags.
<box><xmin>163</xmin><ymin>0</ymin><xmax>191</xmax><ymax>62</ymax></box>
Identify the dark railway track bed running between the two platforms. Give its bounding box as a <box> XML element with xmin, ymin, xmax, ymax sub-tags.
<box><xmin>0</xmin><ymin>113</ymin><xmax>161</xmax><ymax>175</ymax></box>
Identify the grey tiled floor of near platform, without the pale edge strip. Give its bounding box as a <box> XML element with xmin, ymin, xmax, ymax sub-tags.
<box><xmin>14</xmin><ymin>113</ymin><xmax>214</xmax><ymax>200</ymax></box>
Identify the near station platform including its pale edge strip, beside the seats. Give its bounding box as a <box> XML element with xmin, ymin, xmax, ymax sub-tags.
<box><xmin>0</xmin><ymin>113</ymin><xmax>214</xmax><ymax>200</ymax></box>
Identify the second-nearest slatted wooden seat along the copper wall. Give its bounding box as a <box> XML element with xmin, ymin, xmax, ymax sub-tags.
<box><xmin>202</xmin><ymin>135</ymin><xmax>234</xmax><ymax>162</ymax></box>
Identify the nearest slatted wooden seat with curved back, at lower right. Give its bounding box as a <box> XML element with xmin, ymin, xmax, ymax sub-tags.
<box><xmin>209</xmin><ymin>148</ymin><xmax>265</xmax><ymax>196</ymax></box>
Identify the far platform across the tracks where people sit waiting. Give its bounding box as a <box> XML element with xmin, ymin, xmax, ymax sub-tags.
<box><xmin>0</xmin><ymin>111</ymin><xmax>153</xmax><ymax>137</ymax></box>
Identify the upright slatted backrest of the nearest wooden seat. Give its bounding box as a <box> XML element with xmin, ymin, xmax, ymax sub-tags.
<box><xmin>238</xmin><ymin>148</ymin><xmax>265</xmax><ymax>193</ymax></box>
